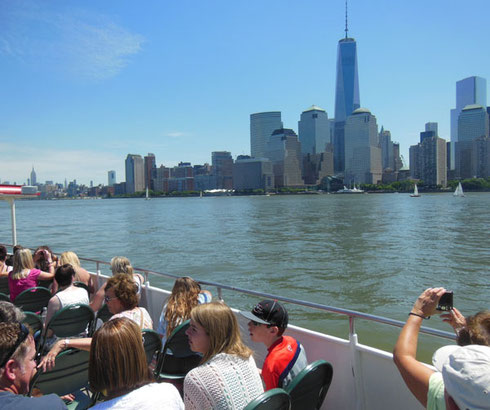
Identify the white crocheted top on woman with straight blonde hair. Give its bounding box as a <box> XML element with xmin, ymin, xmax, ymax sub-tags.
<box><xmin>184</xmin><ymin>353</ymin><xmax>264</xmax><ymax>410</ymax></box>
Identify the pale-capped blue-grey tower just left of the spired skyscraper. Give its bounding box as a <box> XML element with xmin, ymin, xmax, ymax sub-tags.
<box><xmin>298</xmin><ymin>105</ymin><xmax>331</xmax><ymax>155</ymax></box>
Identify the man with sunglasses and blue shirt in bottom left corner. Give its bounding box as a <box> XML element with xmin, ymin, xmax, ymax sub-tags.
<box><xmin>0</xmin><ymin>322</ymin><xmax>66</xmax><ymax>410</ymax></box>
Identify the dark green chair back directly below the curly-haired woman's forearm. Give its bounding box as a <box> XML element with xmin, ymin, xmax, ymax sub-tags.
<box><xmin>29</xmin><ymin>349</ymin><xmax>90</xmax><ymax>398</ymax></box>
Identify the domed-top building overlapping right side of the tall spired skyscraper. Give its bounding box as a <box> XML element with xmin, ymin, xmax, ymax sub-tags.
<box><xmin>342</xmin><ymin>108</ymin><xmax>382</xmax><ymax>184</ymax></box>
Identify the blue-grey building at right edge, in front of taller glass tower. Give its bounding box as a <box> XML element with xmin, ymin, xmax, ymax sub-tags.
<box><xmin>454</xmin><ymin>104</ymin><xmax>489</xmax><ymax>179</ymax></box>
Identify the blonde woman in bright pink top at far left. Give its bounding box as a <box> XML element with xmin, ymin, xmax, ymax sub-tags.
<box><xmin>9</xmin><ymin>249</ymin><xmax>54</xmax><ymax>302</ymax></box>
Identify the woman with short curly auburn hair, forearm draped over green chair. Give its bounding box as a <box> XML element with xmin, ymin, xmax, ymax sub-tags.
<box><xmin>40</xmin><ymin>274</ymin><xmax>153</xmax><ymax>370</ymax></box>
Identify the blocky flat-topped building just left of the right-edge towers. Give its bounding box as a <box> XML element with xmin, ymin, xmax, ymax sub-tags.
<box><xmin>410</xmin><ymin>131</ymin><xmax>447</xmax><ymax>187</ymax></box>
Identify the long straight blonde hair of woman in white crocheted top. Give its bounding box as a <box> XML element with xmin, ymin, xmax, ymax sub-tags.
<box><xmin>191</xmin><ymin>302</ymin><xmax>253</xmax><ymax>363</ymax></box>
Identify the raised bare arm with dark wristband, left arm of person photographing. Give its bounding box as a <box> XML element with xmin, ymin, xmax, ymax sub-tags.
<box><xmin>393</xmin><ymin>288</ymin><xmax>446</xmax><ymax>407</ymax></box>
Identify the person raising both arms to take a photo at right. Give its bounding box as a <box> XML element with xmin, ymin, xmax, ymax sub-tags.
<box><xmin>393</xmin><ymin>288</ymin><xmax>490</xmax><ymax>409</ymax></box>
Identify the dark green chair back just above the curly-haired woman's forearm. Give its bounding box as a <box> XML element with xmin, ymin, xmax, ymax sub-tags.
<box><xmin>45</xmin><ymin>304</ymin><xmax>94</xmax><ymax>337</ymax></box>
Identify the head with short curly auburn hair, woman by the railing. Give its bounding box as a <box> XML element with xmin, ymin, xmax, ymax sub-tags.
<box><xmin>104</xmin><ymin>273</ymin><xmax>138</xmax><ymax>314</ymax></box>
